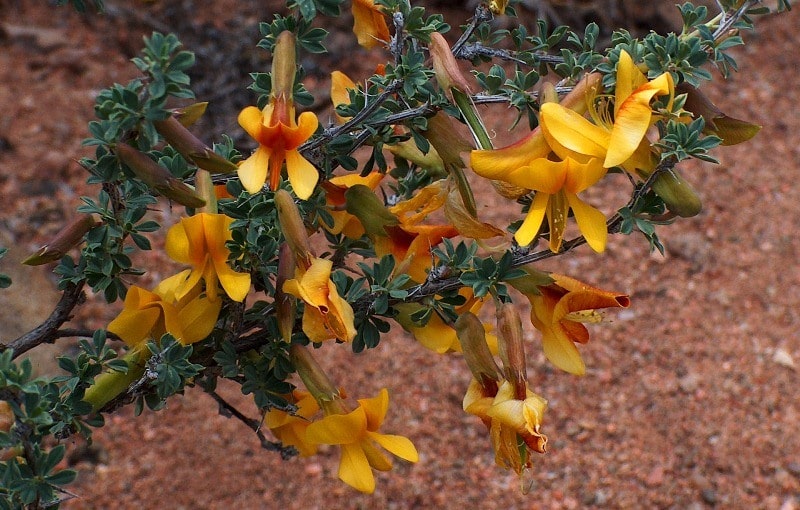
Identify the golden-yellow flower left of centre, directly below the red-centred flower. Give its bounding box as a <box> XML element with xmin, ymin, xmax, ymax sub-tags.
<box><xmin>166</xmin><ymin>213</ymin><xmax>250</xmax><ymax>302</ymax></box>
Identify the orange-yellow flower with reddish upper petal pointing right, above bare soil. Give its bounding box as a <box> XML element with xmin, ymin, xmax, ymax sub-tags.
<box><xmin>528</xmin><ymin>274</ymin><xmax>630</xmax><ymax>375</ymax></box>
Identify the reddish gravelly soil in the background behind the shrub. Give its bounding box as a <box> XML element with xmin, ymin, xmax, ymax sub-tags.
<box><xmin>0</xmin><ymin>1</ymin><xmax>800</xmax><ymax>510</ymax></box>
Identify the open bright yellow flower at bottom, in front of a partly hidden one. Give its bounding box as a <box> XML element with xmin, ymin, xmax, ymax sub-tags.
<box><xmin>306</xmin><ymin>388</ymin><xmax>419</xmax><ymax>494</ymax></box>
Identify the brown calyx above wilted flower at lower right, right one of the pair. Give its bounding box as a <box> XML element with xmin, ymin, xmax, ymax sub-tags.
<box><xmin>497</xmin><ymin>303</ymin><xmax>528</xmax><ymax>400</ymax></box>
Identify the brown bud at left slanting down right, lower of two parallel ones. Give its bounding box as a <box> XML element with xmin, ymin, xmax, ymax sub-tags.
<box><xmin>114</xmin><ymin>142</ymin><xmax>206</xmax><ymax>209</ymax></box>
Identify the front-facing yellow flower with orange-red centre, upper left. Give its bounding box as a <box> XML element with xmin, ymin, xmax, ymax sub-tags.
<box><xmin>238</xmin><ymin>97</ymin><xmax>319</xmax><ymax>200</ymax></box>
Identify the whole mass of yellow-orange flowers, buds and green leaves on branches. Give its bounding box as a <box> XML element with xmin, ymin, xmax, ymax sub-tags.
<box><xmin>12</xmin><ymin>0</ymin><xmax>772</xmax><ymax>504</ymax></box>
